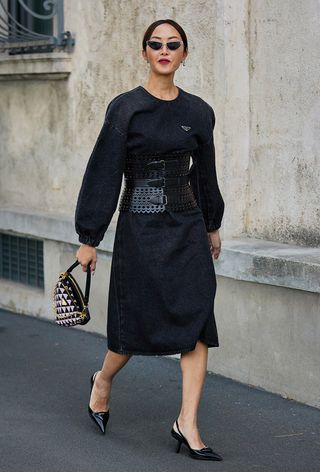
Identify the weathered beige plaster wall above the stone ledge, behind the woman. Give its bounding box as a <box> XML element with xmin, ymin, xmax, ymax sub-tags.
<box><xmin>0</xmin><ymin>0</ymin><xmax>320</xmax><ymax>246</ymax></box>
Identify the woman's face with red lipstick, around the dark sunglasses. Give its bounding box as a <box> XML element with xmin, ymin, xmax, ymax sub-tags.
<box><xmin>142</xmin><ymin>23</ymin><xmax>187</xmax><ymax>75</ymax></box>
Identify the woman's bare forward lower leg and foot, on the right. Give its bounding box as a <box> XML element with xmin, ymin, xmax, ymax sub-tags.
<box><xmin>174</xmin><ymin>341</ymin><xmax>208</xmax><ymax>449</ymax></box>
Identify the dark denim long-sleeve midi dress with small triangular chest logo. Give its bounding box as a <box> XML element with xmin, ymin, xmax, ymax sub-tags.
<box><xmin>75</xmin><ymin>85</ymin><xmax>224</xmax><ymax>355</ymax></box>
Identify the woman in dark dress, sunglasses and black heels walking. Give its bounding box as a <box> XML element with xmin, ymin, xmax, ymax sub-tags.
<box><xmin>75</xmin><ymin>19</ymin><xmax>224</xmax><ymax>460</ymax></box>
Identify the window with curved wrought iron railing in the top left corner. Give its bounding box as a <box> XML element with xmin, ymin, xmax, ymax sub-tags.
<box><xmin>0</xmin><ymin>0</ymin><xmax>75</xmax><ymax>54</ymax></box>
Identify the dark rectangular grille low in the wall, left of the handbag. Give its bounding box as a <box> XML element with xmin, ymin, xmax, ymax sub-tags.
<box><xmin>0</xmin><ymin>233</ymin><xmax>44</xmax><ymax>288</ymax></box>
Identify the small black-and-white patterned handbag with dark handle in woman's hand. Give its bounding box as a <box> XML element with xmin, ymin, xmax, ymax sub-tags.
<box><xmin>52</xmin><ymin>260</ymin><xmax>91</xmax><ymax>326</ymax></box>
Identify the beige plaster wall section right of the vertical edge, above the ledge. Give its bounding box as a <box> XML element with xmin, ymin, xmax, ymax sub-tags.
<box><xmin>246</xmin><ymin>0</ymin><xmax>320</xmax><ymax>246</ymax></box>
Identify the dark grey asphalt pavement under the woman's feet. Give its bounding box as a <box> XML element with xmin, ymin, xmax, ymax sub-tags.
<box><xmin>0</xmin><ymin>310</ymin><xmax>320</xmax><ymax>472</ymax></box>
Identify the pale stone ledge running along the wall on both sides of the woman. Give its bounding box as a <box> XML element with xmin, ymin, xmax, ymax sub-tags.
<box><xmin>0</xmin><ymin>208</ymin><xmax>320</xmax><ymax>293</ymax></box>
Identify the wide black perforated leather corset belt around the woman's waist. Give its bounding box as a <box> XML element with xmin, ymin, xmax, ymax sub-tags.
<box><xmin>119</xmin><ymin>152</ymin><xmax>197</xmax><ymax>213</ymax></box>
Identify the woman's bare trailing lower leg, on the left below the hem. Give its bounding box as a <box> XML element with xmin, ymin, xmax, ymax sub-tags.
<box><xmin>89</xmin><ymin>350</ymin><xmax>132</xmax><ymax>412</ymax></box>
